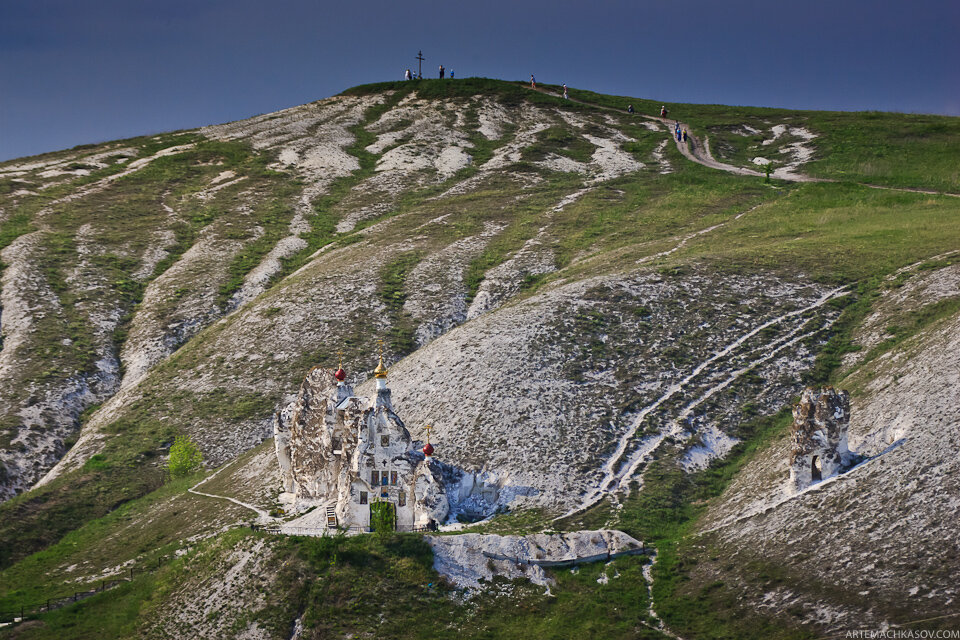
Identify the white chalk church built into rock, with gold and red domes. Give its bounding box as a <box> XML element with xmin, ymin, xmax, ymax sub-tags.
<box><xmin>274</xmin><ymin>352</ymin><xmax>455</xmax><ymax>531</ymax></box>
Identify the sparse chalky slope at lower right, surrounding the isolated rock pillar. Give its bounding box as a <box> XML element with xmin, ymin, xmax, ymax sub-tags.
<box><xmin>695</xmin><ymin>268</ymin><xmax>960</xmax><ymax>633</ymax></box>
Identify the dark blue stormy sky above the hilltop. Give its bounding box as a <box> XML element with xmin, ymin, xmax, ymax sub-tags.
<box><xmin>0</xmin><ymin>0</ymin><xmax>960</xmax><ymax>160</ymax></box>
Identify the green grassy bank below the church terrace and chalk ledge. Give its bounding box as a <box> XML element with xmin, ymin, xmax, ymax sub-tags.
<box><xmin>0</xmin><ymin>529</ymin><xmax>663</xmax><ymax>639</ymax></box>
